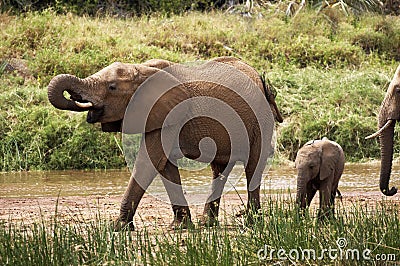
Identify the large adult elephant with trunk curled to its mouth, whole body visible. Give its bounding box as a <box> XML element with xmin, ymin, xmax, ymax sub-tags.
<box><xmin>48</xmin><ymin>57</ymin><xmax>282</xmax><ymax>229</ymax></box>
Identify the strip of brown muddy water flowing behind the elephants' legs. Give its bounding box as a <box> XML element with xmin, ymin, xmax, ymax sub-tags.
<box><xmin>0</xmin><ymin>163</ymin><xmax>400</xmax><ymax>198</ymax></box>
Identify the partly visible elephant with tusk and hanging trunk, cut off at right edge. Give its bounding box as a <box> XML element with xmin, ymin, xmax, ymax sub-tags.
<box><xmin>366</xmin><ymin>66</ymin><xmax>400</xmax><ymax>196</ymax></box>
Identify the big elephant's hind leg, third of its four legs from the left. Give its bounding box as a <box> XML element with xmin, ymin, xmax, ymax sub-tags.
<box><xmin>200</xmin><ymin>162</ymin><xmax>235</xmax><ymax>226</ymax></box>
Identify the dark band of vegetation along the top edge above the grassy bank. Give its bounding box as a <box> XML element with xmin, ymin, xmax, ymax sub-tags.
<box><xmin>0</xmin><ymin>0</ymin><xmax>399</xmax><ymax>17</ymax></box>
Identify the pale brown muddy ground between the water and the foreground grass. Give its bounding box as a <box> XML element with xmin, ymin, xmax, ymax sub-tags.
<box><xmin>0</xmin><ymin>191</ymin><xmax>400</xmax><ymax>230</ymax></box>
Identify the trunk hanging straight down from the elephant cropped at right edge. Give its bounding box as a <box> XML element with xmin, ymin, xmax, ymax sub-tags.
<box><xmin>379</xmin><ymin>121</ymin><xmax>397</xmax><ymax>196</ymax></box>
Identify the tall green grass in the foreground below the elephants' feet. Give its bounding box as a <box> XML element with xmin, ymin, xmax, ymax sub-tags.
<box><xmin>0</xmin><ymin>195</ymin><xmax>400</xmax><ymax>265</ymax></box>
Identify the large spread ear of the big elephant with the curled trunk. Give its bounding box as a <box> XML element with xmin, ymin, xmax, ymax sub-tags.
<box><xmin>122</xmin><ymin>70</ymin><xmax>189</xmax><ymax>134</ymax></box>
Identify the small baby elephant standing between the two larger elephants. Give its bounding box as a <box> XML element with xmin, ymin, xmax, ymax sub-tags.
<box><xmin>295</xmin><ymin>138</ymin><xmax>344</xmax><ymax>219</ymax></box>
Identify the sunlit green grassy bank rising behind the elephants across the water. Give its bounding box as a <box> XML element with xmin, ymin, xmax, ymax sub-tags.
<box><xmin>0</xmin><ymin>9</ymin><xmax>400</xmax><ymax>171</ymax></box>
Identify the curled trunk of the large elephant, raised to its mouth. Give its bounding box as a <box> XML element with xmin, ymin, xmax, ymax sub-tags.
<box><xmin>47</xmin><ymin>74</ymin><xmax>91</xmax><ymax>112</ymax></box>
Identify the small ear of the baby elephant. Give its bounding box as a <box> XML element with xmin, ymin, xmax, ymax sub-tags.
<box><xmin>319</xmin><ymin>140</ymin><xmax>339</xmax><ymax>180</ymax></box>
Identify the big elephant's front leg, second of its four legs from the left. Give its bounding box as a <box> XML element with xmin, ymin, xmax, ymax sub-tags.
<box><xmin>160</xmin><ymin>161</ymin><xmax>192</xmax><ymax>229</ymax></box>
